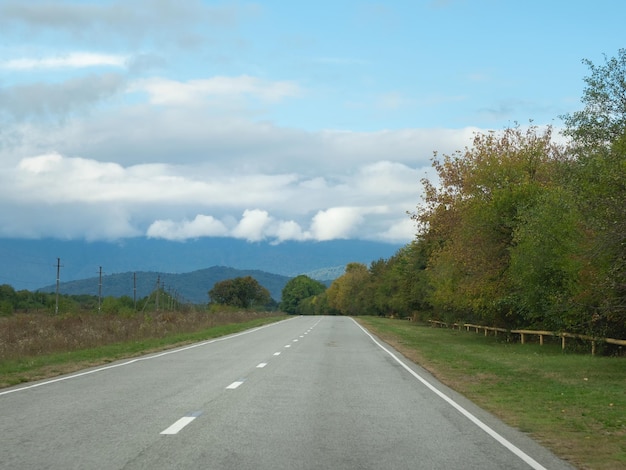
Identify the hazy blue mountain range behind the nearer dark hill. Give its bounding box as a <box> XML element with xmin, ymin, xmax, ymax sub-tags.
<box><xmin>0</xmin><ymin>237</ymin><xmax>403</xmax><ymax>294</ymax></box>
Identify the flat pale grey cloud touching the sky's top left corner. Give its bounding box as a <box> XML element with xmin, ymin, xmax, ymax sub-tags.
<box><xmin>0</xmin><ymin>0</ymin><xmax>258</xmax><ymax>48</ymax></box>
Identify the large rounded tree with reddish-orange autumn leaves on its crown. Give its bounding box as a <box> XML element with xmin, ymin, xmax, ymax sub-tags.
<box><xmin>413</xmin><ymin>126</ymin><xmax>564</xmax><ymax>326</ymax></box>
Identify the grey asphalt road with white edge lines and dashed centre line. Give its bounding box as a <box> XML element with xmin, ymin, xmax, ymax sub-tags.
<box><xmin>0</xmin><ymin>317</ymin><xmax>571</xmax><ymax>470</ymax></box>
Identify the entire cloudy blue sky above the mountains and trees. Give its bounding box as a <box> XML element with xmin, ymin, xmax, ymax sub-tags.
<box><xmin>0</xmin><ymin>0</ymin><xmax>626</xmax><ymax>243</ymax></box>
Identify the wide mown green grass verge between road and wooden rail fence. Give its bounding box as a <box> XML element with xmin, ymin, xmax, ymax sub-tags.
<box><xmin>358</xmin><ymin>317</ymin><xmax>626</xmax><ymax>470</ymax></box>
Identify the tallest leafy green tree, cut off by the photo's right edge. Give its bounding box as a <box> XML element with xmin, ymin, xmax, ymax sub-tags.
<box><xmin>564</xmin><ymin>49</ymin><xmax>626</xmax><ymax>337</ymax></box>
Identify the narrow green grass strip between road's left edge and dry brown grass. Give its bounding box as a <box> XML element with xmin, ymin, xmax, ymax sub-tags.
<box><xmin>0</xmin><ymin>315</ymin><xmax>287</xmax><ymax>388</ymax></box>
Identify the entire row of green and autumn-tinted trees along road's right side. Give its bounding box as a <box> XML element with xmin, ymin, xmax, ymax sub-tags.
<box><xmin>286</xmin><ymin>49</ymin><xmax>626</xmax><ymax>338</ymax></box>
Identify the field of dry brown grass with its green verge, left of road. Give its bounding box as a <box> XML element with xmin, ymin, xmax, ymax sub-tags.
<box><xmin>0</xmin><ymin>310</ymin><xmax>284</xmax><ymax>387</ymax></box>
